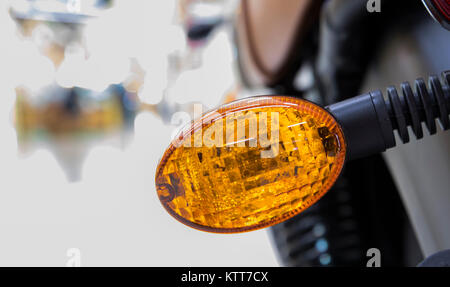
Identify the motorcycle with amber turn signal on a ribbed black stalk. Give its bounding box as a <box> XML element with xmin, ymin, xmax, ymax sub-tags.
<box><xmin>156</xmin><ymin>0</ymin><xmax>450</xmax><ymax>266</ymax></box>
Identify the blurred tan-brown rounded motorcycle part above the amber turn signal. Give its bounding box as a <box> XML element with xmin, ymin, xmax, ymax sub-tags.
<box><xmin>235</xmin><ymin>0</ymin><xmax>322</xmax><ymax>94</ymax></box>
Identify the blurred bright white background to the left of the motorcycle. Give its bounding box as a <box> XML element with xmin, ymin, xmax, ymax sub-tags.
<box><xmin>0</xmin><ymin>0</ymin><xmax>278</xmax><ymax>266</ymax></box>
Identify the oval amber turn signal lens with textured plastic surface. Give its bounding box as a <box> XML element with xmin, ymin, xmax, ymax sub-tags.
<box><xmin>156</xmin><ymin>96</ymin><xmax>345</xmax><ymax>233</ymax></box>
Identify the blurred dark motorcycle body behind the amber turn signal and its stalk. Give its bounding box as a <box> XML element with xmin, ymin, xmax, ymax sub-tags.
<box><xmin>236</xmin><ymin>1</ymin><xmax>450</xmax><ymax>266</ymax></box>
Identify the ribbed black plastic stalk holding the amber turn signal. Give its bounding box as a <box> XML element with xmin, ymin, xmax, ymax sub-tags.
<box><xmin>326</xmin><ymin>71</ymin><xmax>450</xmax><ymax>160</ymax></box>
